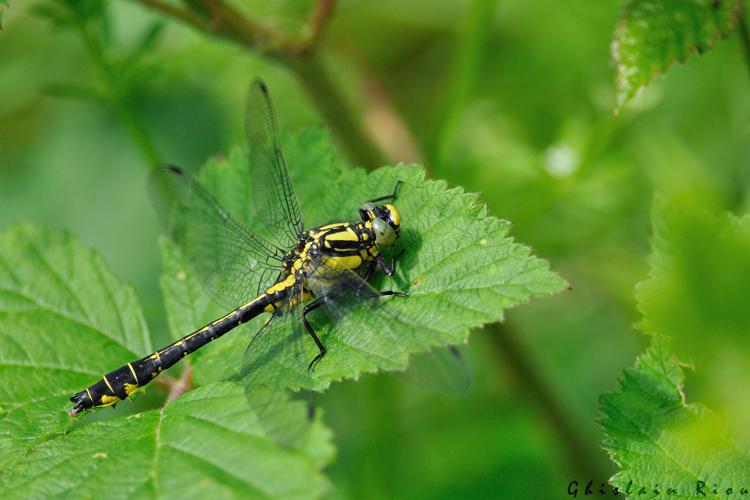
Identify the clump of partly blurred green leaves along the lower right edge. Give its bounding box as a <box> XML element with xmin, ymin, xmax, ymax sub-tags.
<box><xmin>601</xmin><ymin>197</ymin><xmax>750</xmax><ymax>497</ymax></box>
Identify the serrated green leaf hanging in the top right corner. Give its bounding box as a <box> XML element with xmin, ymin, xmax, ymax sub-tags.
<box><xmin>612</xmin><ymin>0</ymin><xmax>742</xmax><ymax>111</ymax></box>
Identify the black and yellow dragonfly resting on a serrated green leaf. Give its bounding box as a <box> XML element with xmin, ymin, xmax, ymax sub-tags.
<box><xmin>69</xmin><ymin>80</ymin><xmax>406</xmax><ymax>416</ymax></box>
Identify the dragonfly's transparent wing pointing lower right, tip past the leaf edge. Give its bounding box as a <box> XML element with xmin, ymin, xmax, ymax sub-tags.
<box><xmin>308</xmin><ymin>260</ymin><xmax>471</xmax><ymax>393</ymax></box>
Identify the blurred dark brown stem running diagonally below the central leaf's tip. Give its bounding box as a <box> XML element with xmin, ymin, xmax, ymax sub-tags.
<box><xmin>485</xmin><ymin>323</ymin><xmax>610</xmax><ymax>482</ymax></box>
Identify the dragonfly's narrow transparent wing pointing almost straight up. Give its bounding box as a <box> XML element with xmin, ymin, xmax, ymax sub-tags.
<box><xmin>245</xmin><ymin>80</ymin><xmax>304</xmax><ymax>248</ymax></box>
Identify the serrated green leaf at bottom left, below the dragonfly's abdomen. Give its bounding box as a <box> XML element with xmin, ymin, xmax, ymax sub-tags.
<box><xmin>0</xmin><ymin>382</ymin><xmax>331</xmax><ymax>498</ymax></box>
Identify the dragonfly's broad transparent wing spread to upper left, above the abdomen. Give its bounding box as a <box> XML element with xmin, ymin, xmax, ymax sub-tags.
<box><xmin>150</xmin><ymin>165</ymin><xmax>283</xmax><ymax>309</ymax></box>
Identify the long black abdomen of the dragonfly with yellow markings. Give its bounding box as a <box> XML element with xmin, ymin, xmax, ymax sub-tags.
<box><xmin>70</xmin><ymin>293</ymin><xmax>273</xmax><ymax>416</ymax></box>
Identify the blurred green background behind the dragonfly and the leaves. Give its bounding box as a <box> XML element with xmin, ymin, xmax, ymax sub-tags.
<box><xmin>0</xmin><ymin>0</ymin><xmax>750</xmax><ymax>498</ymax></box>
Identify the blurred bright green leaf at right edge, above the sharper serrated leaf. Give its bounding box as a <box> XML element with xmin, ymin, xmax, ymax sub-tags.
<box><xmin>636</xmin><ymin>197</ymin><xmax>750</xmax><ymax>364</ymax></box>
